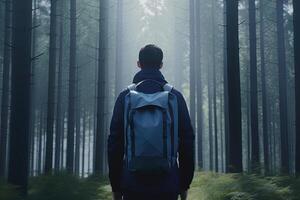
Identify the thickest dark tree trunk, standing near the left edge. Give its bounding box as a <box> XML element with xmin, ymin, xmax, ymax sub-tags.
<box><xmin>8</xmin><ymin>0</ymin><xmax>32</xmax><ymax>195</ymax></box>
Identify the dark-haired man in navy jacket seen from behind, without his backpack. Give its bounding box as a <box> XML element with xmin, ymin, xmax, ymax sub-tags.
<box><xmin>108</xmin><ymin>45</ymin><xmax>195</xmax><ymax>200</ymax></box>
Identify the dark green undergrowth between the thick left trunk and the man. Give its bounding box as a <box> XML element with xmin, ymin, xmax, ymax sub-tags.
<box><xmin>27</xmin><ymin>173</ymin><xmax>110</xmax><ymax>200</ymax></box>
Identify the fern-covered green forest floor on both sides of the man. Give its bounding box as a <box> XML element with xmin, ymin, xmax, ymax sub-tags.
<box><xmin>0</xmin><ymin>172</ymin><xmax>300</xmax><ymax>200</ymax></box>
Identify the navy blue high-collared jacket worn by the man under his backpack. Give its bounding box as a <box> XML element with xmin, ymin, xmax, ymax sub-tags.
<box><xmin>107</xmin><ymin>68</ymin><xmax>195</xmax><ymax>193</ymax></box>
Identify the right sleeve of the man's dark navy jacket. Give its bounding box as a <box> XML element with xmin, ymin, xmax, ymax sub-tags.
<box><xmin>178</xmin><ymin>91</ymin><xmax>195</xmax><ymax>191</ymax></box>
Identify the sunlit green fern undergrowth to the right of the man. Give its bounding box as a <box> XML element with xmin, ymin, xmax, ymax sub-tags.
<box><xmin>190</xmin><ymin>172</ymin><xmax>300</xmax><ymax>200</ymax></box>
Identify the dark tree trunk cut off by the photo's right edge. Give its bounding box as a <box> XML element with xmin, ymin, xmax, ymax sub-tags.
<box><xmin>293</xmin><ymin>0</ymin><xmax>300</xmax><ymax>174</ymax></box>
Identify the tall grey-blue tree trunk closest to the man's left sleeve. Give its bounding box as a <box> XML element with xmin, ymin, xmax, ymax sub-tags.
<box><xmin>95</xmin><ymin>0</ymin><xmax>107</xmax><ymax>175</ymax></box>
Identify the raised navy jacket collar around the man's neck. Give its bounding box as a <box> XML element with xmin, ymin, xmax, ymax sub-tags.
<box><xmin>133</xmin><ymin>68</ymin><xmax>167</xmax><ymax>84</ymax></box>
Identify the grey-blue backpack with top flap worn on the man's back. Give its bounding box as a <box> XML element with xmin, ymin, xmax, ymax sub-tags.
<box><xmin>124</xmin><ymin>80</ymin><xmax>178</xmax><ymax>174</ymax></box>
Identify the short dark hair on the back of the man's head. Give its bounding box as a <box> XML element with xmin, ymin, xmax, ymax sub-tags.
<box><xmin>139</xmin><ymin>44</ymin><xmax>164</xmax><ymax>67</ymax></box>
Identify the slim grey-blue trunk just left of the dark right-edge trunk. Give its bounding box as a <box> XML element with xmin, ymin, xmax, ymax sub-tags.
<box><xmin>276</xmin><ymin>0</ymin><xmax>290</xmax><ymax>174</ymax></box>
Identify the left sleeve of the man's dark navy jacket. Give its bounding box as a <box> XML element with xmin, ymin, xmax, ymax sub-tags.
<box><xmin>107</xmin><ymin>93</ymin><xmax>124</xmax><ymax>192</ymax></box>
